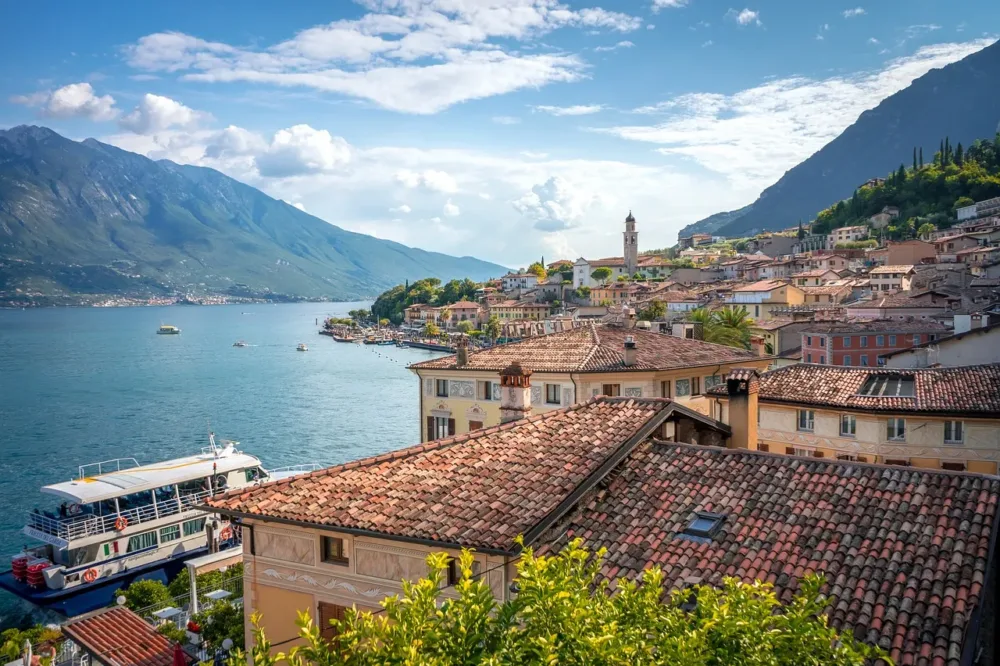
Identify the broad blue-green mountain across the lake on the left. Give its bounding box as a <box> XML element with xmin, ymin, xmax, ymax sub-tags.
<box><xmin>0</xmin><ymin>126</ymin><xmax>507</xmax><ymax>300</ymax></box>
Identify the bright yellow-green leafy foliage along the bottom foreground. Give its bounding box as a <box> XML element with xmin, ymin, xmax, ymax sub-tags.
<box><xmin>229</xmin><ymin>540</ymin><xmax>888</xmax><ymax>666</ymax></box>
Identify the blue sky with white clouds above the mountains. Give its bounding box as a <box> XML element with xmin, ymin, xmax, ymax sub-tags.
<box><xmin>0</xmin><ymin>0</ymin><xmax>1000</xmax><ymax>266</ymax></box>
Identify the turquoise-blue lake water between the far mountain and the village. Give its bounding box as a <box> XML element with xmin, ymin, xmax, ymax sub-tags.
<box><xmin>0</xmin><ymin>303</ymin><xmax>439</xmax><ymax>625</ymax></box>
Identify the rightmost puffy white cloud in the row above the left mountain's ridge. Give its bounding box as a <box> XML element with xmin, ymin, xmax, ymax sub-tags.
<box><xmin>256</xmin><ymin>125</ymin><xmax>351</xmax><ymax>178</ymax></box>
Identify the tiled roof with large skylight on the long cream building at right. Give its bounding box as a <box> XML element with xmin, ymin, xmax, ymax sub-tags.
<box><xmin>708</xmin><ymin>360</ymin><xmax>1000</xmax><ymax>417</ymax></box>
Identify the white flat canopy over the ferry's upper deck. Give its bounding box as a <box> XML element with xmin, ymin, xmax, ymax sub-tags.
<box><xmin>42</xmin><ymin>451</ymin><xmax>260</xmax><ymax>504</ymax></box>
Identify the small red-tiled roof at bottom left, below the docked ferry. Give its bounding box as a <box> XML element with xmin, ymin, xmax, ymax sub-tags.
<box><xmin>62</xmin><ymin>607</ymin><xmax>182</xmax><ymax>666</ymax></box>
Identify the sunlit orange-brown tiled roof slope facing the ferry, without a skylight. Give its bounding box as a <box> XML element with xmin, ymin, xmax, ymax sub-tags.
<box><xmin>207</xmin><ymin>398</ymin><xmax>684</xmax><ymax>552</ymax></box>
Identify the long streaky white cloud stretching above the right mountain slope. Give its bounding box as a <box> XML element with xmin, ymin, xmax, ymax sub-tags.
<box><xmin>594</xmin><ymin>40</ymin><xmax>993</xmax><ymax>190</ymax></box>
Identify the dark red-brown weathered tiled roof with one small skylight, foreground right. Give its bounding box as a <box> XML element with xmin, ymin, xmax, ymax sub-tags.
<box><xmin>542</xmin><ymin>441</ymin><xmax>1000</xmax><ymax>666</ymax></box>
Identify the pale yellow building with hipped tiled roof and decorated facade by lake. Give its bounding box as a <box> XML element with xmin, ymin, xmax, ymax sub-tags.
<box><xmin>410</xmin><ymin>324</ymin><xmax>770</xmax><ymax>441</ymax></box>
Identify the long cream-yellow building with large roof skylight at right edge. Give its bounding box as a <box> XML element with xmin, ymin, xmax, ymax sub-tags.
<box><xmin>711</xmin><ymin>364</ymin><xmax>1000</xmax><ymax>474</ymax></box>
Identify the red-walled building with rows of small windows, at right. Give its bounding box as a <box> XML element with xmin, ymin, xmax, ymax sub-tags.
<box><xmin>801</xmin><ymin>319</ymin><xmax>949</xmax><ymax>367</ymax></box>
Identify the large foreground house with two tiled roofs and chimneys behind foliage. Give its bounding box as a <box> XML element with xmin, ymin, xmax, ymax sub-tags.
<box><xmin>207</xmin><ymin>366</ymin><xmax>1000</xmax><ymax>664</ymax></box>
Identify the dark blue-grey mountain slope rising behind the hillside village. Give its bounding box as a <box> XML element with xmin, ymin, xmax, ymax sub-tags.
<box><xmin>696</xmin><ymin>42</ymin><xmax>1000</xmax><ymax>237</ymax></box>
